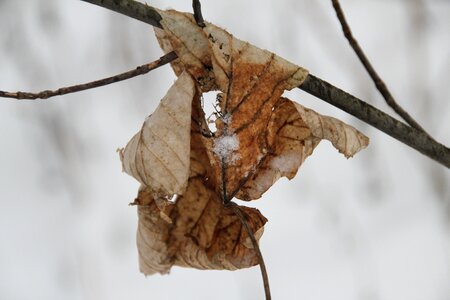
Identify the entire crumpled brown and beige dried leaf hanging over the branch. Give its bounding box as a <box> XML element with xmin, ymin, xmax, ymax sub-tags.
<box><xmin>122</xmin><ymin>10</ymin><xmax>368</xmax><ymax>275</ymax></box>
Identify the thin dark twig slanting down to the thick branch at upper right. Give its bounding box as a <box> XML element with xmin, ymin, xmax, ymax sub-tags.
<box><xmin>331</xmin><ymin>0</ymin><xmax>431</xmax><ymax>138</ymax></box>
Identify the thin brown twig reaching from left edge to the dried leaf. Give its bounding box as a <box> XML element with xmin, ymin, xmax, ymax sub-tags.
<box><xmin>0</xmin><ymin>52</ymin><xmax>177</xmax><ymax>100</ymax></box>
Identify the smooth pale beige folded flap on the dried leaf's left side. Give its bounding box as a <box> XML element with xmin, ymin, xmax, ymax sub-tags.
<box><xmin>121</xmin><ymin>73</ymin><xmax>196</xmax><ymax>196</ymax></box>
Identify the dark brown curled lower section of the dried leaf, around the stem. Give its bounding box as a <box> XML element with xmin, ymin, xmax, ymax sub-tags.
<box><xmin>135</xmin><ymin>96</ymin><xmax>266</xmax><ymax>275</ymax></box>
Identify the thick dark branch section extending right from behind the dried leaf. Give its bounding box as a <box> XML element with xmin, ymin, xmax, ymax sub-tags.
<box><xmin>299</xmin><ymin>74</ymin><xmax>450</xmax><ymax>168</ymax></box>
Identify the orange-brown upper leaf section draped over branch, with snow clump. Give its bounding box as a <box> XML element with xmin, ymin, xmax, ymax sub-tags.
<box><xmin>156</xmin><ymin>11</ymin><xmax>308</xmax><ymax>201</ymax></box>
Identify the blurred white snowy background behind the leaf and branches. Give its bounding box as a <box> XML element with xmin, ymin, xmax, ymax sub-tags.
<box><xmin>0</xmin><ymin>0</ymin><xmax>450</xmax><ymax>300</ymax></box>
